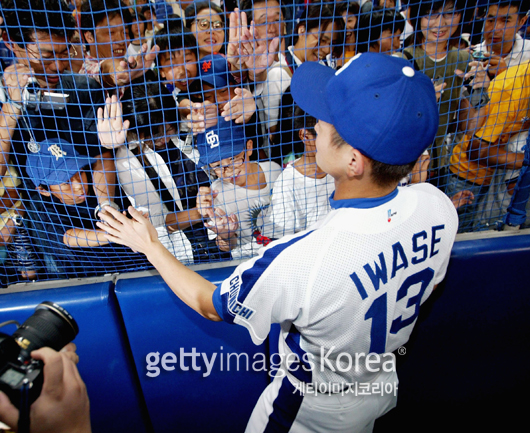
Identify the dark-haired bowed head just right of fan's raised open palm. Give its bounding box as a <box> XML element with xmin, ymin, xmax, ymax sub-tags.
<box><xmin>121</xmin><ymin>71</ymin><xmax>178</xmax><ymax>148</ymax></box>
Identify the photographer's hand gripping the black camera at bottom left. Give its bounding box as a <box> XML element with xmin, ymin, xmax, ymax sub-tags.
<box><xmin>0</xmin><ymin>343</ymin><xmax>91</xmax><ymax>433</ymax></box>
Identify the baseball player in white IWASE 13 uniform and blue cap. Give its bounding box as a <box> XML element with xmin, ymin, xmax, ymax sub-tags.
<box><xmin>100</xmin><ymin>53</ymin><xmax>458</xmax><ymax>432</ymax></box>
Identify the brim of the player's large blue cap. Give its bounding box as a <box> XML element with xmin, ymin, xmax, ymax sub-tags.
<box><xmin>291</xmin><ymin>62</ymin><xmax>335</xmax><ymax>123</ymax></box>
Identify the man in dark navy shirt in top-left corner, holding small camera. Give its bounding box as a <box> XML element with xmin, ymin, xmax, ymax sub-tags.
<box><xmin>0</xmin><ymin>0</ymin><xmax>115</xmax><ymax>214</ymax></box>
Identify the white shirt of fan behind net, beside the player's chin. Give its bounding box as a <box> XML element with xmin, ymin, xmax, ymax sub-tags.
<box><xmin>265</xmin><ymin>165</ymin><xmax>335</xmax><ymax>239</ymax></box>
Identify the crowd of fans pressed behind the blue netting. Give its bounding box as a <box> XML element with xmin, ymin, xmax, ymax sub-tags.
<box><xmin>0</xmin><ymin>0</ymin><xmax>530</xmax><ymax>283</ymax></box>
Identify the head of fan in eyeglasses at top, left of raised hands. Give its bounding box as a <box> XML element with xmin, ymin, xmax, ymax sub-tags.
<box><xmin>185</xmin><ymin>1</ymin><xmax>225</xmax><ymax>59</ymax></box>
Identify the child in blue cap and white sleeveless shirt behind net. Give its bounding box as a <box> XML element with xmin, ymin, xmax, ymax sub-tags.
<box><xmin>197</xmin><ymin>118</ymin><xmax>281</xmax><ymax>258</ymax></box>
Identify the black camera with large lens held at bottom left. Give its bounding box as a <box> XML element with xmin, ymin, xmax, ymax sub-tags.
<box><xmin>0</xmin><ymin>301</ymin><xmax>79</xmax><ymax>409</ymax></box>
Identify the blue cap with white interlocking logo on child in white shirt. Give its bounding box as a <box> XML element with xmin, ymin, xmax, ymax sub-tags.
<box><xmin>197</xmin><ymin>117</ymin><xmax>247</xmax><ymax>167</ymax></box>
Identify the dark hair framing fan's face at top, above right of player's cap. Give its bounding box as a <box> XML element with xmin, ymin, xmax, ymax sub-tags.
<box><xmin>408</xmin><ymin>0</ymin><xmax>470</xmax><ymax>44</ymax></box>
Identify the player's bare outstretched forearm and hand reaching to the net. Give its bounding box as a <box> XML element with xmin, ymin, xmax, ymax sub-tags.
<box><xmin>97</xmin><ymin>206</ymin><xmax>221</xmax><ymax>321</ymax></box>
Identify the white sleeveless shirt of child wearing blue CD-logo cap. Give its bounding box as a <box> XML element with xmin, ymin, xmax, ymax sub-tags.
<box><xmin>211</xmin><ymin>161</ymin><xmax>281</xmax><ymax>259</ymax></box>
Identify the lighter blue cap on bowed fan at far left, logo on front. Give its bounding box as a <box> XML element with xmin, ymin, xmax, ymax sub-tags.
<box><xmin>26</xmin><ymin>138</ymin><xmax>96</xmax><ymax>186</ymax></box>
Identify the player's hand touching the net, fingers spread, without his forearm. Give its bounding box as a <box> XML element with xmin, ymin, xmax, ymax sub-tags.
<box><xmin>96</xmin><ymin>206</ymin><xmax>160</xmax><ymax>255</ymax></box>
